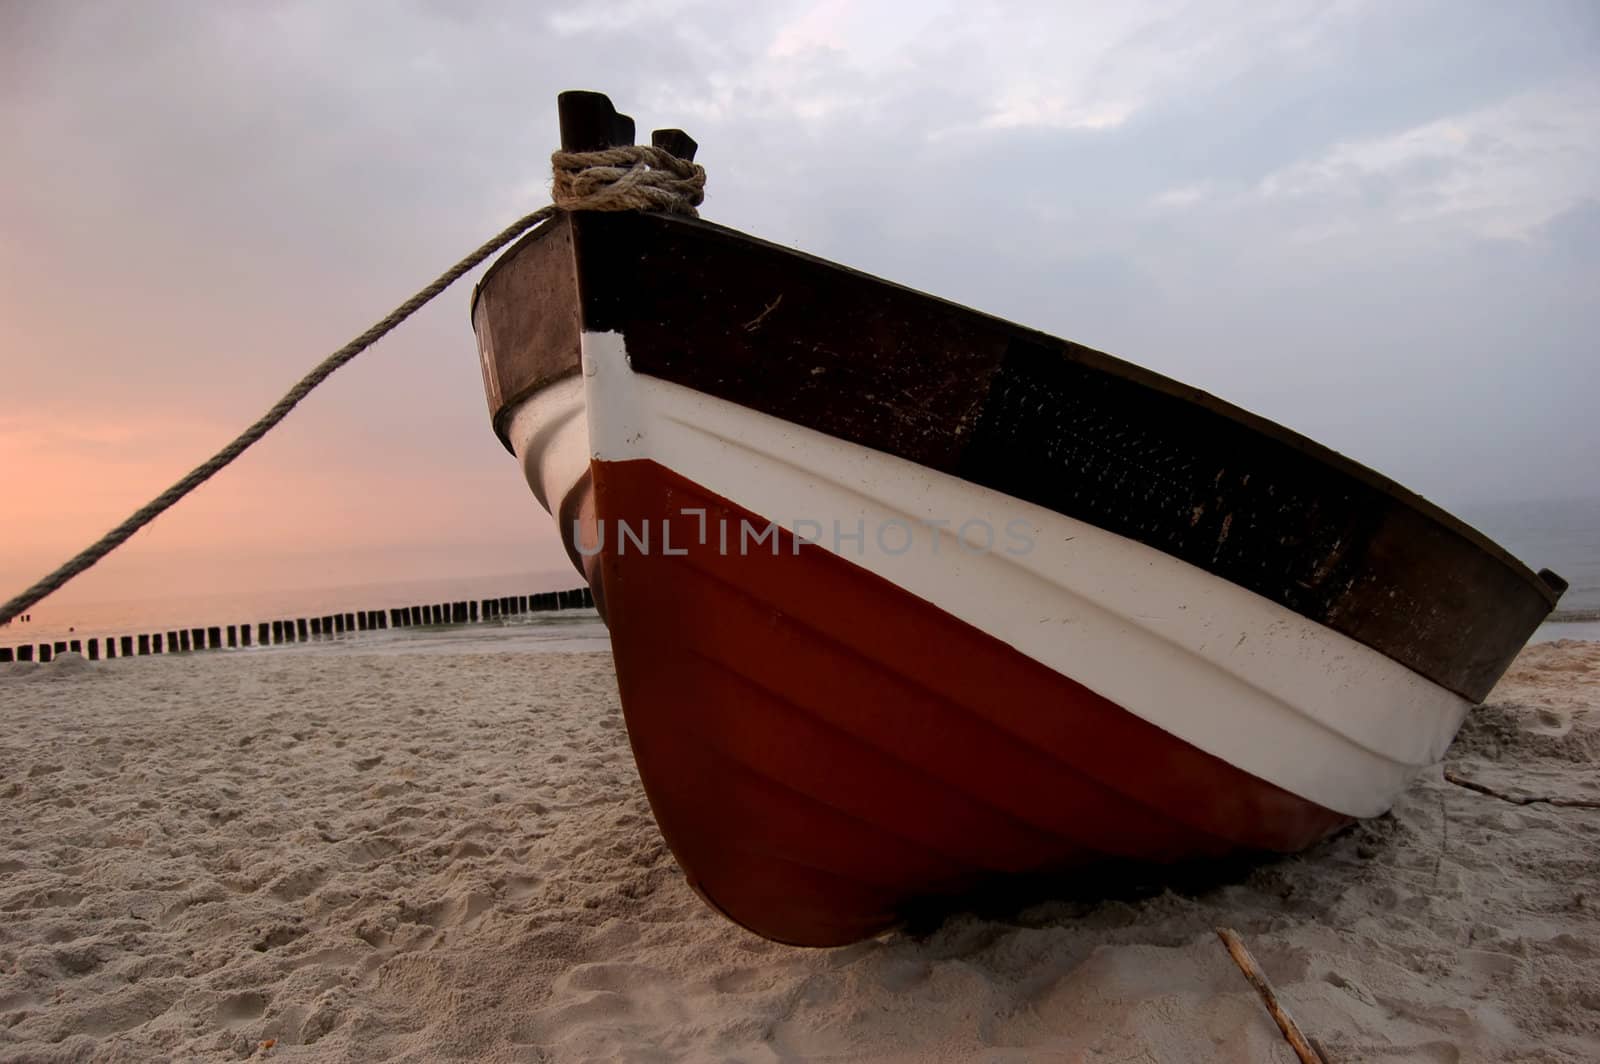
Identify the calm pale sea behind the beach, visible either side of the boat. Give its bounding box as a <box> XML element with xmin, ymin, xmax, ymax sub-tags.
<box><xmin>0</xmin><ymin>499</ymin><xmax>1600</xmax><ymax>653</ymax></box>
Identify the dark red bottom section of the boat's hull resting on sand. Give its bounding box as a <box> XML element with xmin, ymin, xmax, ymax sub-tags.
<box><xmin>582</xmin><ymin>461</ymin><xmax>1347</xmax><ymax>946</ymax></box>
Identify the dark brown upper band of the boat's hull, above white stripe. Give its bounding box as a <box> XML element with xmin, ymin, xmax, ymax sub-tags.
<box><xmin>474</xmin><ymin>213</ymin><xmax>1560</xmax><ymax>701</ymax></box>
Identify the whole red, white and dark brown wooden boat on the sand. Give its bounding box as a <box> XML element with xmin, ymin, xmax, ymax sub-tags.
<box><xmin>472</xmin><ymin>94</ymin><xmax>1565</xmax><ymax>946</ymax></box>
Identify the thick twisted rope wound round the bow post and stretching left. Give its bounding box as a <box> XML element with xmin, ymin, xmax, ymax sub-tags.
<box><xmin>0</xmin><ymin>144</ymin><xmax>706</xmax><ymax>624</ymax></box>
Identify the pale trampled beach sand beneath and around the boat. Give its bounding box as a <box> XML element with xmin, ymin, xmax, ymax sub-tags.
<box><xmin>0</xmin><ymin>642</ymin><xmax>1600</xmax><ymax>1064</ymax></box>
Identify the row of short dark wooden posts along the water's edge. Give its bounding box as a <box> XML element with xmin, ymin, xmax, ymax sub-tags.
<box><xmin>0</xmin><ymin>587</ymin><xmax>595</xmax><ymax>664</ymax></box>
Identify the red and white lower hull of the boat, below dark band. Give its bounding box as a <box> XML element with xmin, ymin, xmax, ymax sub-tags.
<box><xmin>492</xmin><ymin>334</ymin><xmax>1467</xmax><ymax>946</ymax></box>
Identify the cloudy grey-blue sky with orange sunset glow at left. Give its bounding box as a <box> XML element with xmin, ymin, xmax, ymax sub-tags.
<box><xmin>0</xmin><ymin>0</ymin><xmax>1600</xmax><ymax>611</ymax></box>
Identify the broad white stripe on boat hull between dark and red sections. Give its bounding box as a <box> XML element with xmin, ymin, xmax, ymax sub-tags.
<box><xmin>509</xmin><ymin>333</ymin><xmax>1469</xmax><ymax>816</ymax></box>
